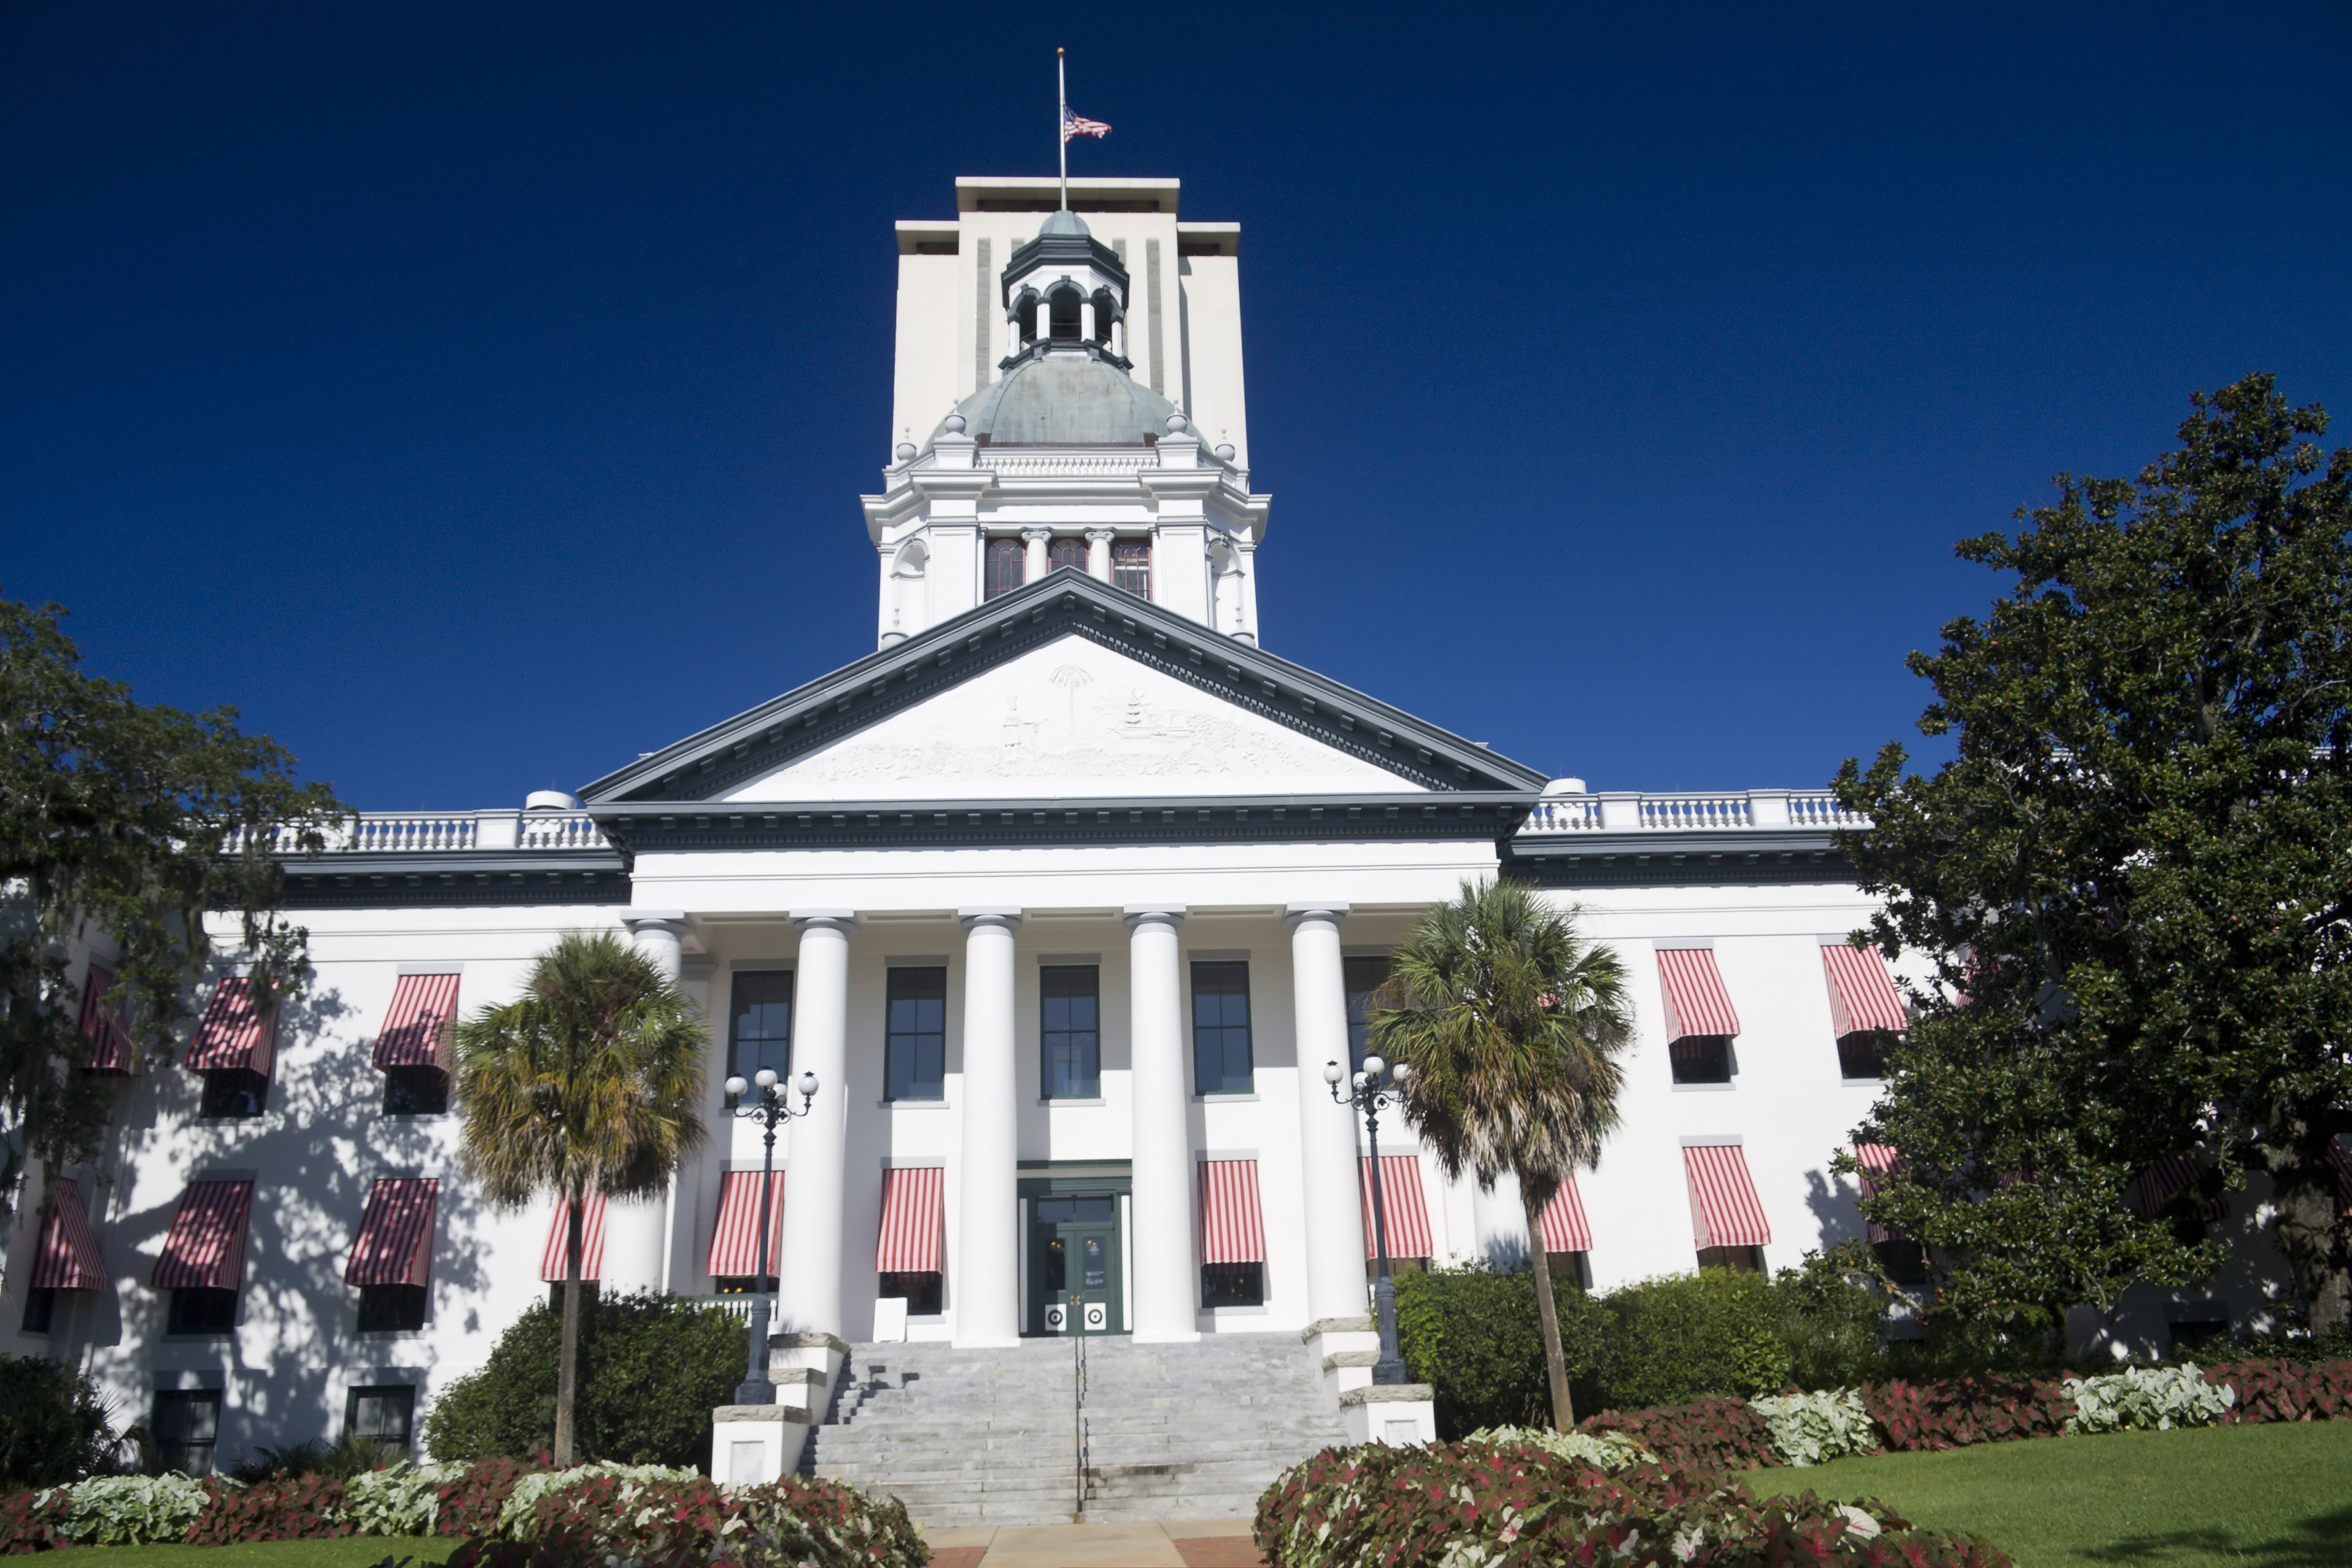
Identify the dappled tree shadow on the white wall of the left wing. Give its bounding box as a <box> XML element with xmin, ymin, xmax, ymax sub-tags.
<box><xmin>86</xmin><ymin>973</ymin><xmax>504</xmax><ymax>1469</ymax></box>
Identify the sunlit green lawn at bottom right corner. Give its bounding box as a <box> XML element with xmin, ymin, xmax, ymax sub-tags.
<box><xmin>1743</xmin><ymin>1422</ymin><xmax>2352</xmax><ymax>1568</ymax></box>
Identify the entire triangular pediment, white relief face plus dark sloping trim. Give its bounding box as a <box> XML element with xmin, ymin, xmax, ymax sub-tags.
<box><xmin>581</xmin><ymin>571</ymin><xmax>1545</xmax><ymax>809</ymax></box>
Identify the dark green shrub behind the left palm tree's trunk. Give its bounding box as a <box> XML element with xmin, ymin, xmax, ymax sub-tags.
<box><xmin>425</xmin><ymin>1293</ymin><xmax>743</xmax><ymax>1469</ymax></box>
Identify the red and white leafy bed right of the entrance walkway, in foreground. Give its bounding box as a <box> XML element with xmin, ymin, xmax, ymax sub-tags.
<box><xmin>1256</xmin><ymin>1444</ymin><xmax>2009</xmax><ymax>1568</ymax></box>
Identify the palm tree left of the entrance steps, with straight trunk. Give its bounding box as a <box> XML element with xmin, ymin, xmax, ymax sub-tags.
<box><xmin>457</xmin><ymin>931</ymin><xmax>706</xmax><ymax>1467</ymax></box>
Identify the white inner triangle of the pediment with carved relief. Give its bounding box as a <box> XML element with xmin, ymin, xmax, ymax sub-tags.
<box><xmin>717</xmin><ymin>632</ymin><xmax>1423</xmax><ymax>804</ymax></box>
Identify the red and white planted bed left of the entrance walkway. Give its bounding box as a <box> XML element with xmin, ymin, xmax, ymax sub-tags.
<box><xmin>0</xmin><ymin>1460</ymin><xmax>931</xmax><ymax>1568</ymax></box>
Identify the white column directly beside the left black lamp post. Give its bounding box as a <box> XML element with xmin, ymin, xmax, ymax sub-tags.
<box><xmin>776</xmin><ymin>910</ymin><xmax>858</xmax><ymax>1338</ymax></box>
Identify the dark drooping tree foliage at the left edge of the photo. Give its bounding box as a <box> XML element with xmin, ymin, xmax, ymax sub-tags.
<box><xmin>0</xmin><ymin>600</ymin><xmax>348</xmax><ymax>1192</ymax></box>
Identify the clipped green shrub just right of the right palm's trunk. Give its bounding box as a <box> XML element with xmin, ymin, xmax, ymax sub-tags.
<box><xmin>1599</xmin><ymin>1269</ymin><xmax>1792</xmax><ymax>1410</ymax></box>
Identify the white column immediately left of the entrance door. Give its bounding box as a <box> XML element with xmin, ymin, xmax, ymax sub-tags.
<box><xmin>948</xmin><ymin>910</ymin><xmax>1021</xmax><ymax>1345</ymax></box>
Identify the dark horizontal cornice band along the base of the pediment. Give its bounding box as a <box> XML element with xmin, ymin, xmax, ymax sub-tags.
<box><xmin>598</xmin><ymin>792</ymin><xmax>1529</xmax><ymax>854</ymax></box>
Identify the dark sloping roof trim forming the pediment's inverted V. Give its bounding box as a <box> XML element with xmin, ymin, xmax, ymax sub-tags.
<box><xmin>578</xmin><ymin>566</ymin><xmax>1545</xmax><ymax>811</ymax></box>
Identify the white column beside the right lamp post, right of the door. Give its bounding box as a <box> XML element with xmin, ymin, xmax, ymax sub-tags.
<box><xmin>1284</xmin><ymin>903</ymin><xmax>1366</xmax><ymax>1324</ymax></box>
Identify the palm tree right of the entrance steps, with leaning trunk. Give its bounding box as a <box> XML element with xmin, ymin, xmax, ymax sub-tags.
<box><xmin>1371</xmin><ymin>882</ymin><xmax>1633</xmax><ymax>1432</ymax></box>
